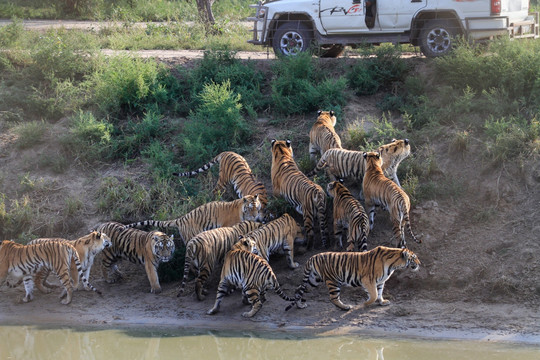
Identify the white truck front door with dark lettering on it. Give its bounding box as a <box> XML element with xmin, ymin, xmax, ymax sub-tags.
<box><xmin>319</xmin><ymin>0</ymin><xmax>368</xmax><ymax>34</ymax></box>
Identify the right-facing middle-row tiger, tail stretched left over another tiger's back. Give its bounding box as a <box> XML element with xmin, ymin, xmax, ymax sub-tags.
<box><xmin>126</xmin><ymin>194</ymin><xmax>264</xmax><ymax>245</ymax></box>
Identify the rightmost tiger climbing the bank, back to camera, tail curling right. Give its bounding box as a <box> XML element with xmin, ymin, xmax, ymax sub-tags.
<box><xmin>362</xmin><ymin>152</ymin><xmax>422</xmax><ymax>248</ymax></box>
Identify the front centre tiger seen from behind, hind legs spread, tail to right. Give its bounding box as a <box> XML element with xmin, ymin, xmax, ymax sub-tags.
<box><xmin>207</xmin><ymin>242</ymin><xmax>295</xmax><ymax>318</ymax></box>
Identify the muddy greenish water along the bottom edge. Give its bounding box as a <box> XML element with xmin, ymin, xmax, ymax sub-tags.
<box><xmin>0</xmin><ymin>326</ymin><xmax>540</xmax><ymax>360</ymax></box>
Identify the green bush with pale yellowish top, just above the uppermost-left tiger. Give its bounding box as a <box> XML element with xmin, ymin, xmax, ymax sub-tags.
<box><xmin>180</xmin><ymin>81</ymin><xmax>251</xmax><ymax>166</ymax></box>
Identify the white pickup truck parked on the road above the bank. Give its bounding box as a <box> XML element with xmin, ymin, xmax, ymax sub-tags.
<box><xmin>248</xmin><ymin>0</ymin><xmax>538</xmax><ymax>57</ymax></box>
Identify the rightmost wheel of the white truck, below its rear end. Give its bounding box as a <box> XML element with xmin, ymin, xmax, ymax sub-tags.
<box><xmin>419</xmin><ymin>20</ymin><xmax>458</xmax><ymax>57</ymax></box>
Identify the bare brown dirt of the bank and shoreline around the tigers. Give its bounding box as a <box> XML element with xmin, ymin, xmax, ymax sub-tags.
<box><xmin>0</xmin><ymin>52</ymin><xmax>540</xmax><ymax>345</ymax></box>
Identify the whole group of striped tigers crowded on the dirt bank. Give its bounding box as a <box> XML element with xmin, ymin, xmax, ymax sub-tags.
<box><xmin>0</xmin><ymin>111</ymin><xmax>421</xmax><ymax>317</ymax></box>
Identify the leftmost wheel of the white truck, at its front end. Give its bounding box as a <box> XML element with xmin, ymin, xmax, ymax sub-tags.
<box><xmin>272</xmin><ymin>21</ymin><xmax>311</xmax><ymax>56</ymax></box>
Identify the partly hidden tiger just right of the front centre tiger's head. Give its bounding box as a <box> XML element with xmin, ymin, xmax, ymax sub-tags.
<box><xmin>245</xmin><ymin>214</ymin><xmax>304</xmax><ymax>269</ymax></box>
